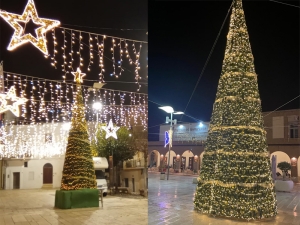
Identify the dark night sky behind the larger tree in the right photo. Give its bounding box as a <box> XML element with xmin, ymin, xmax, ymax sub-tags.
<box><xmin>148</xmin><ymin>0</ymin><xmax>300</xmax><ymax>141</ymax></box>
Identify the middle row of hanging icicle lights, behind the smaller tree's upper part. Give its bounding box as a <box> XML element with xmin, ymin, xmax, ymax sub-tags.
<box><xmin>4</xmin><ymin>73</ymin><xmax>148</xmax><ymax>129</ymax></box>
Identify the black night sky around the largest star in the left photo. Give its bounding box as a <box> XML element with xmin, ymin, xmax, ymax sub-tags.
<box><xmin>0</xmin><ymin>0</ymin><xmax>148</xmax><ymax>93</ymax></box>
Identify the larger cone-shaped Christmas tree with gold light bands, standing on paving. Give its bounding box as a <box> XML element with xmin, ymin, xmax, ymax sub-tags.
<box><xmin>194</xmin><ymin>0</ymin><xmax>277</xmax><ymax>220</ymax></box>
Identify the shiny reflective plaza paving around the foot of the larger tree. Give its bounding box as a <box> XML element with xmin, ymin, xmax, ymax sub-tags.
<box><xmin>148</xmin><ymin>172</ymin><xmax>300</xmax><ymax>225</ymax></box>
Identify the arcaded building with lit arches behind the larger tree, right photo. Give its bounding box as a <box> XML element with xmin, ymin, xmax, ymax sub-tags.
<box><xmin>148</xmin><ymin>109</ymin><xmax>300</xmax><ymax>178</ymax></box>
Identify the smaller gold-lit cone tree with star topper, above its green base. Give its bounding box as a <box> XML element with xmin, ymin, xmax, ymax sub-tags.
<box><xmin>61</xmin><ymin>70</ymin><xmax>97</xmax><ymax>190</ymax></box>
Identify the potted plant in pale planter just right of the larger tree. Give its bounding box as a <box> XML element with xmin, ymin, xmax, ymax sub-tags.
<box><xmin>275</xmin><ymin>162</ymin><xmax>294</xmax><ymax>192</ymax></box>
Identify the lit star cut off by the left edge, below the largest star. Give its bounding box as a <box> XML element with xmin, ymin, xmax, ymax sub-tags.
<box><xmin>0</xmin><ymin>86</ymin><xmax>28</xmax><ymax>117</ymax></box>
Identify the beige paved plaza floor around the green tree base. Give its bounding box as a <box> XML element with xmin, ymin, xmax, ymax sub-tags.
<box><xmin>0</xmin><ymin>189</ymin><xmax>148</xmax><ymax>225</ymax></box>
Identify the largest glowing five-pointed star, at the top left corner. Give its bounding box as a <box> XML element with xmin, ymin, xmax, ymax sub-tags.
<box><xmin>0</xmin><ymin>0</ymin><xmax>60</xmax><ymax>55</ymax></box>
